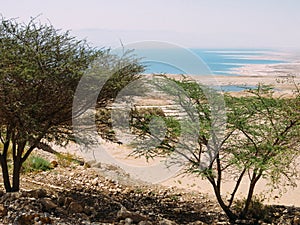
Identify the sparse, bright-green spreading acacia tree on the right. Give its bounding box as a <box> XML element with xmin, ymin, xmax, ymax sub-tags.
<box><xmin>131</xmin><ymin>75</ymin><xmax>300</xmax><ymax>221</ymax></box>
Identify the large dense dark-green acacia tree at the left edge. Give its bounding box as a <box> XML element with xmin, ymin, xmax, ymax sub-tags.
<box><xmin>0</xmin><ymin>18</ymin><xmax>142</xmax><ymax>192</ymax></box>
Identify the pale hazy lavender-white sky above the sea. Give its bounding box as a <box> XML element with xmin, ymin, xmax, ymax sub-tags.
<box><xmin>0</xmin><ymin>0</ymin><xmax>300</xmax><ymax>49</ymax></box>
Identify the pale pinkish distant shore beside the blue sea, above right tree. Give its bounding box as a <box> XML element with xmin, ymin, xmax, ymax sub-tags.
<box><xmin>157</xmin><ymin>53</ymin><xmax>300</xmax><ymax>95</ymax></box>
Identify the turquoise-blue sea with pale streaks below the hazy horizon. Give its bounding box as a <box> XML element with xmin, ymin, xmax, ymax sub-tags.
<box><xmin>136</xmin><ymin>48</ymin><xmax>286</xmax><ymax>91</ymax></box>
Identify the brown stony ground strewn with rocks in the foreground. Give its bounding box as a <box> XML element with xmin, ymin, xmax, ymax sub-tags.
<box><xmin>0</xmin><ymin>150</ymin><xmax>300</xmax><ymax>225</ymax></box>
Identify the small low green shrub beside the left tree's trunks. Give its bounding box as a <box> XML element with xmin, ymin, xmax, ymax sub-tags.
<box><xmin>23</xmin><ymin>155</ymin><xmax>53</xmax><ymax>173</ymax></box>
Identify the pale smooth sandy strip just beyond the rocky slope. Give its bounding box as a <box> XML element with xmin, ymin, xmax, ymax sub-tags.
<box><xmin>56</xmin><ymin>140</ymin><xmax>300</xmax><ymax>207</ymax></box>
